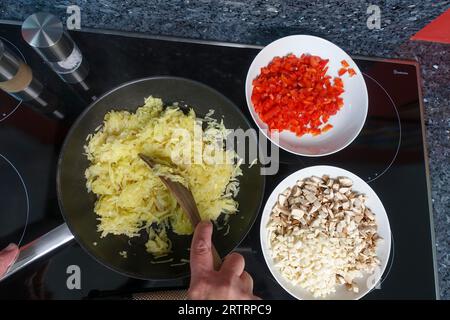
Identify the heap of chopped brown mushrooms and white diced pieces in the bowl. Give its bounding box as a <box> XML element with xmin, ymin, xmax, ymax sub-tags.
<box><xmin>267</xmin><ymin>176</ymin><xmax>380</xmax><ymax>297</ymax></box>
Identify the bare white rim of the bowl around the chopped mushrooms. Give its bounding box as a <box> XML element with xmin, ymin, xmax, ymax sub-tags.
<box><xmin>260</xmin><ymin>166</ymin><xmax>391</xmax><ymax>300</ymax></box>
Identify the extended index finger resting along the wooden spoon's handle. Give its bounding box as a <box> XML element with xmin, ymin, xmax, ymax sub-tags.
<box><xmin>190</xmin><ymin>221</ymin><xmax>213</xmax><ymax>277</ymax></box>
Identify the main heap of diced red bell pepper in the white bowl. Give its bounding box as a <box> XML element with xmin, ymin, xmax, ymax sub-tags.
<box><xmin>251</xmin><ymin>54</ymin><xmax>345</xmax><ymax>136</ymax></box>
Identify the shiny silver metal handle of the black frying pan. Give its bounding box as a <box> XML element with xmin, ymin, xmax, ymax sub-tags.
<box><xmin>0</xmin><ymin>223</ymin><xmax>73</xmax><ymax>281</ymax></box>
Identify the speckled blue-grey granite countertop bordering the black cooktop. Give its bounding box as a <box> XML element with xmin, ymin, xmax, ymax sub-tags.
<box><xmin>0</xmin><ymin>0</ymin><xmax>450</xmax><ymax>299</ymax></box>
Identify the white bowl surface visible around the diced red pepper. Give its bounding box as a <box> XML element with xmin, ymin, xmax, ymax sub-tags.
<box><xmin>245</xmin><ymin>35</ymin><xmax>369</xmax><ymax>157</ymax></box>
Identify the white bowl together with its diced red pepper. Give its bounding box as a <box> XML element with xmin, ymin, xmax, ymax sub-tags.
<box><xmin>245</xmin><ymin>35</ymin><xmax>368</xmax><ymax>157</ymax></box>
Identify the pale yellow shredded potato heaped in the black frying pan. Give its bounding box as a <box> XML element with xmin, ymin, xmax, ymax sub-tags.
<box><xmin>85</xmin><ymin>97</ymin><xmax>242</xmax><ymax>257</ymax></box>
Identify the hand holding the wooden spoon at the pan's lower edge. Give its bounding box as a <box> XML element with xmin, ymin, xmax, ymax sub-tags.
<box><xmin>188</xmin><ymin>221</ymin><xmax>259</xmax><ymax>300</ymax></box>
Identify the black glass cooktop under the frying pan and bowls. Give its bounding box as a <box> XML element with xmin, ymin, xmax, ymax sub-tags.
<box><xmin>0</xmin><ymin>24</ymin><xmax>437</xmax><ymax>299</ymax></box>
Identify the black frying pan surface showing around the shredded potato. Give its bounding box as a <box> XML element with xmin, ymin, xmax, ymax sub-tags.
<box><xmin>57</xmin><ymin>77</ymin><xmax>265</xmax><ymax>280</ymax></box>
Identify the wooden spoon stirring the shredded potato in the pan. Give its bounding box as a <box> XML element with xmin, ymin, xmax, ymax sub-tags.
<box><xmin>139</xmin><ymin>153</ymin><xmax>222</xmax><ymax>270</ymax></box>
